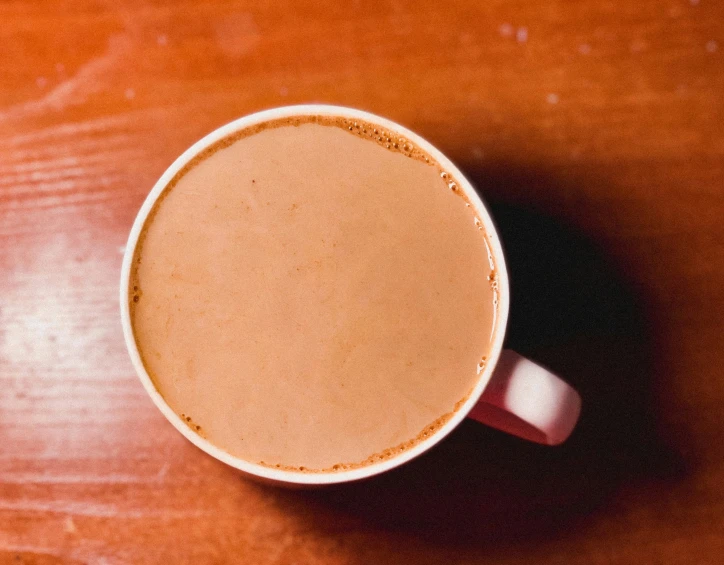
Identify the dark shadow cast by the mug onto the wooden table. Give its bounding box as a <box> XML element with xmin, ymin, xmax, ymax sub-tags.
<box><xmin>258</xmin><ymin>165</ymin><xmax>683</xmax><ymax>546</ymax></box>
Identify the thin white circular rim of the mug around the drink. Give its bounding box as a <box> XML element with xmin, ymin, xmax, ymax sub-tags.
<box><xmin>120</xmin><ymin>105</ymin><xmax>509</xmax><ymax>484</ymax></box>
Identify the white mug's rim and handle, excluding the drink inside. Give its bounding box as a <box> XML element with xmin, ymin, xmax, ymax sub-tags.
<box><xmin>121</xmin><ymin>104</ymin><xmax>581</xmax><ymax>486</ymax></box>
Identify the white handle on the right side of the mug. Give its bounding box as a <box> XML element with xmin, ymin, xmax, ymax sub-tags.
<box><xmin>468</xmin><ymin>350</ymin><xmax>581</xmax><ymax>445</ymax></box>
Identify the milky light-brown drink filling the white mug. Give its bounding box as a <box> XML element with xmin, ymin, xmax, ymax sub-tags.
<box><xmin>130</xmin><ymin>117</ymin><xmax>495</xmax><ymax>472</ymax></box>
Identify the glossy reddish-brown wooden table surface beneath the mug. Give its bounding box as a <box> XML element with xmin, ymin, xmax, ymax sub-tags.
<box><xmin>0</xmin><ymin>0</ymin><xmax>724</xmax><ymax>565</ymax></box>
